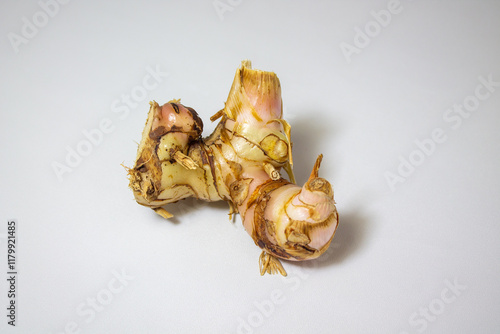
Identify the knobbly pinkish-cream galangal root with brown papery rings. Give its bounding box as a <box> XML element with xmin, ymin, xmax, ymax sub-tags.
<box><xmin>129</xmin><ymin>61</ymin><xmax>338</xmax><ymax>276</ymax></box>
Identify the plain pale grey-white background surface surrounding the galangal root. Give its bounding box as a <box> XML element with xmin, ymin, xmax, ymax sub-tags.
<box><xmin>0</xmin><ymin>0</ymin><xmax>500</xmax><ymax>334</ymax></box>
